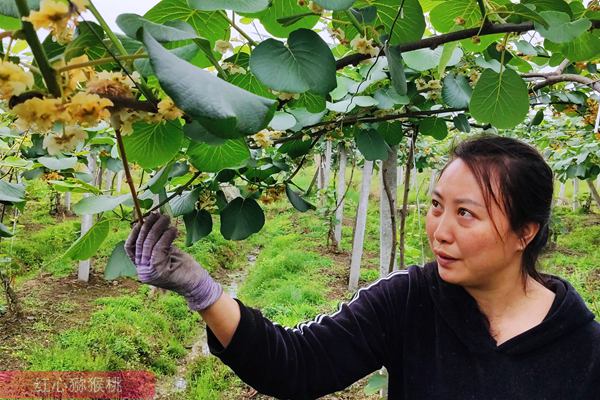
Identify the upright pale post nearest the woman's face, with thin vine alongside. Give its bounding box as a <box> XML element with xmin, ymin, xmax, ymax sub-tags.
<box><xmin>379</xmin><ymin>146</ymin><xmax>398</xmax><ymax>277</ymax></box>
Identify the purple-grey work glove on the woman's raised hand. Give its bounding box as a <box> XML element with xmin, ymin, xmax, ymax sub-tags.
<box><xmin>125</xmin><ymin>213</ymin><xmax>223</xmax><ymax>310</ymax></box>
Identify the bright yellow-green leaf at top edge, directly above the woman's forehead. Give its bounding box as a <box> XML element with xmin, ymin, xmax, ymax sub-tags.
<box><xmin>429</xmin><ymin>0</ymin><xmax>481</xmax><ymax>33</ymax></box>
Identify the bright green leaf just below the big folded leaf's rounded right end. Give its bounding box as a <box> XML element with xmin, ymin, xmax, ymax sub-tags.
<box><xmin>187</xmin><ymin>138</ymin><xmax>250</xmax><ymax>172</ymax></box>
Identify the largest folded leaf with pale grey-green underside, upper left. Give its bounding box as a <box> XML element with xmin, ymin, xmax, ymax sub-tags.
<box><xmin>144</xmin><ymin>32</ymin><xmax>276</xmax><ymax>138</ymax></box>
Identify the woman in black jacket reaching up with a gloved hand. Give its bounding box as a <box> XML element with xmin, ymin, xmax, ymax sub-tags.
<box><xmin>126</xmin><ymin>136</ymin><xmax>600</xmax><ymax>400</ymax></box>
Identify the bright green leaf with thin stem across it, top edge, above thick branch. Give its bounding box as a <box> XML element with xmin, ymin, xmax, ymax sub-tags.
<box><xmin>371</xmin><ymin>0</ymin><xmax>425</xmax><ymax>45</ymax></box>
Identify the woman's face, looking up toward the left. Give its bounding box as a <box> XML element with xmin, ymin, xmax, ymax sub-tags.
<box><xmin>427</xmin><ymin>158</ymin><xmax>522</xmax><ymax>288</ymax></box>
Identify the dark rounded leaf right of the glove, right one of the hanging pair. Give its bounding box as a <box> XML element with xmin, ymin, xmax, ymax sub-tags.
<box><xmin>221</xmin><ymin>197</ymin><xmax>265</xmax><ymax>240</ymax></box>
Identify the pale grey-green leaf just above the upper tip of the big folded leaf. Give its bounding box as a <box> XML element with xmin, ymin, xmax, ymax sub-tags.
<box><xmin>116</xmin><ymin>13</ymin><xmax>198</xmax><ymax>42</ymax></box>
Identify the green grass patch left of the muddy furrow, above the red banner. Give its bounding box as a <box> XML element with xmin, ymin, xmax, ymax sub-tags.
<box><xmin>24</xmin><ymin>287</ymin><xmax>200</xmax><ymax>375</ymax></box>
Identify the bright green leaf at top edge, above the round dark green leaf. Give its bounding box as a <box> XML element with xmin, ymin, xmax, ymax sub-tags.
<box><xmin>258</xmin><ymin>0</ymin><xmax>320</xmax><ymax>38</ymax></box>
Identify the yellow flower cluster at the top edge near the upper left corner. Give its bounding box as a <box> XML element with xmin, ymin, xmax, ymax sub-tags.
<box><xmin>23</xmin><ymin>0</ymin><xmax>88</xmax><ymax>43</ymax></box>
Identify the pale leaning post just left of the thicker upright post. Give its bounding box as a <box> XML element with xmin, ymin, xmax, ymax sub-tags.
<box><xmin>348</xmin><ymin>160</ymin><xmax>373</xmax><ymax>291</ymax></box>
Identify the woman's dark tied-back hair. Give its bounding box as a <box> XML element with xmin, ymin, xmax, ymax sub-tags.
<box><xmin>444</xmin><ymin>135</ymin><xmax>553</xmax><ymax>286</ymax></box>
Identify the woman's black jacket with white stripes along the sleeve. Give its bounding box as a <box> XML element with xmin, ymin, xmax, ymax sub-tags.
<box><xmin>208</xmin><ymin>263</ymin><xmax>600</xmax><ymax>400</ymax></box>
